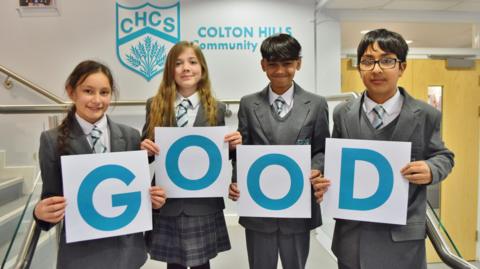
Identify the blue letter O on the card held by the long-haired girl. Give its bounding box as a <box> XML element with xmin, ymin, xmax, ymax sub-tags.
<box><xmin>165</xmin><ymin>135</ymin><xmax>222</xmax><ymax>190</ymax></box>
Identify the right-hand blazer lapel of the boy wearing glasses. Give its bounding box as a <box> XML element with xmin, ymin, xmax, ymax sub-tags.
<box><xmin>392</xmin><ymin>88</ymin><xmax>420</xmax><ymax>141</ymax></box>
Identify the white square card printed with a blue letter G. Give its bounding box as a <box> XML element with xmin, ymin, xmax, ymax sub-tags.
<box><xmin>61</xmin><ymin>151</ymin><xmax>152</xmax><ymax>243</ymax></box>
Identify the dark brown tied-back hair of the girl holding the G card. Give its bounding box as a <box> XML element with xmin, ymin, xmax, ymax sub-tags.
<box><xmin>57</xmin><ymin>60</ymin><xmax>117</xmax><ymax>155</ymax></box>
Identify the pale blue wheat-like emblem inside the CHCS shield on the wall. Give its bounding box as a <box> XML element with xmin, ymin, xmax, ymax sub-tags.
<box><xmin>125</xmin><ymin>36</ymin><xmax>166</xmax><ymax>81</ymax></box>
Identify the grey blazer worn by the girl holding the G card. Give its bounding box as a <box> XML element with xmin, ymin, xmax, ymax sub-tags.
<box><xmin>36</xmin><ymin>118</ymin><xmax>147</xmax><ymax>269</ymax></box>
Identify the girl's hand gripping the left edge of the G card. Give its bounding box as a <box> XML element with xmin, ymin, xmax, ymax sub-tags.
<box><xmin>34</xmin><ymin>196</ymin><xmax>67</xmax><ymax>224</ymax></box>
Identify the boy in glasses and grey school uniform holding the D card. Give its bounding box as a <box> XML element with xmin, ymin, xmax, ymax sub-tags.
<box><xmin>314</xmin><ymin>29</ymin><xmax>454</xmax><ymax>269</ymax></box>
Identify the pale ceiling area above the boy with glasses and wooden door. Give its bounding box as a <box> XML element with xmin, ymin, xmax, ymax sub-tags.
<box><xmin>317</xmin><ymin>0</ymin><xmax>480</xmax><ymax>49</ymax></box>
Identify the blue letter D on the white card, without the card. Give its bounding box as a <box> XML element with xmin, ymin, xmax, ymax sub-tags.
<box><xmin>339</xmin><ymin>148</ymin><xmax>393</xmax><ymax>210</ymax></box>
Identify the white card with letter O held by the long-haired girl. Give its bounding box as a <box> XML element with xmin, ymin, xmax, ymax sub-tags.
<box><xmin>155</xmin><ymin>126</ymin><xmax>230</xmax><ymax>198</ymax></box>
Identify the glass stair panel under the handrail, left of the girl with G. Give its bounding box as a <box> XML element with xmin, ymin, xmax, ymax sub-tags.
<box><xmin>0</xmin><ymin>111</ymin><xmax>61</xmax><ymax>268</ymax></box>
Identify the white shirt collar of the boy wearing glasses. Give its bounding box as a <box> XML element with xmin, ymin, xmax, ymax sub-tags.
<box><xmin>362</xmin><ymin>89</ymin><xmax>403</xmax><ymax>129</ymax></box>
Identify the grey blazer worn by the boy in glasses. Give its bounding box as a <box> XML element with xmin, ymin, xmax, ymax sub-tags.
<box><xmin>332</xmin><ymin>88</ymin><xmax>454</xmax><ymax>268</ymax></box>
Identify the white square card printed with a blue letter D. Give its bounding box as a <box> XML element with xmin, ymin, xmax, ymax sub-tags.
<box><xmin>321</xmin><ymin>138</ymin><xmax>411</xmax><ymax>225</ymax></box>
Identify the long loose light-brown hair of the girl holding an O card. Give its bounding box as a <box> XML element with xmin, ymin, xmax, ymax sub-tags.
<box><xmin>146</xmin><ymin>41</ymin><xmax>217</xmax><ymax>140</ymax></box>
